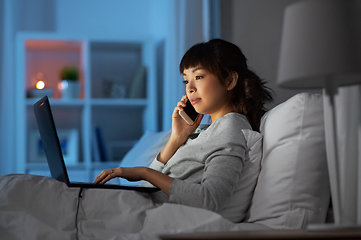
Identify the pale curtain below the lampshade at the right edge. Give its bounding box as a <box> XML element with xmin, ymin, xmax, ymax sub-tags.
<box><xmin>335</xmin><ymin>86</ymin><xmax>361</xmax><ymax>224</ymax></box>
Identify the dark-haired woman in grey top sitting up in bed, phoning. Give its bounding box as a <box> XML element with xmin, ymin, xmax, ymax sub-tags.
<box><xmin>95</xmin><ymin>39</ymin><xmax>272</xmax><ymax>222</ymax></box>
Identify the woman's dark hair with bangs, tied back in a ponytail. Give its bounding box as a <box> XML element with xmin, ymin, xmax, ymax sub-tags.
<box><xmin>179</xmin><ymin>39</ymin><xmax>273</xmax><ymax>131</ymax></box>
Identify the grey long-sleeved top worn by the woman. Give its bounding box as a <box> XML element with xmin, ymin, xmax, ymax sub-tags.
<box><xmin>146</xmin><ymin>113</ymin><xmax>252</xmax><ymax>221</ymax></box>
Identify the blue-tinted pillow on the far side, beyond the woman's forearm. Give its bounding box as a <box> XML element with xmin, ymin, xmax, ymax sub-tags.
<box><xmin>119</xmin><ymin>130</ymin><xmax>171</xmax><ymax>185</ymax></box>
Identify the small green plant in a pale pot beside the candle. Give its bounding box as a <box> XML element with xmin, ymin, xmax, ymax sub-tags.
<box><xmin>60</xmin><ymin>66</ymin><xmax>80</xmax><ymax>99</ymax></box>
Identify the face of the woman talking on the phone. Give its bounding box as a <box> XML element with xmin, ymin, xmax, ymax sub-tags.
<box><xmin>183</xmin><ymin>66</ymin><xmax>233</xmax><ymax>122</ymax></box>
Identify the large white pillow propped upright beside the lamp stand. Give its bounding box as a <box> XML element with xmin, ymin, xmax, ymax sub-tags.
<box><xmin>248</xmin><ymin>93</ymin><xmax>330</xmax><ymax>229</ymax></box>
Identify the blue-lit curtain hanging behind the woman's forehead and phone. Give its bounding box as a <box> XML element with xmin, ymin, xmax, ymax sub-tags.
<box><xmin>163</xmin><ymin>0</ymin><xmax>220</xmax><ymax>129</ymax></box>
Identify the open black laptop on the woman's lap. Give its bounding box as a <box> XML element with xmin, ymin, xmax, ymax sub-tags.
<box><xmin>34</xmin><ymin>96</ymin><xmax>160</xmax><ymax>193</ymax></box>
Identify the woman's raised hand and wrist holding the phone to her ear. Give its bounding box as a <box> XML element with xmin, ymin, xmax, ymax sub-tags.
<box><xmin>158</xmin><ymin>95</ymin><xmax>203</xmax><ymax>164</ymax></box>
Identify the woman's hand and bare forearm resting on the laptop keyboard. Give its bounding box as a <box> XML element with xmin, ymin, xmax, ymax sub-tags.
<box><xmin>94</xmin><ymin>167</ymin><xmax>145</xmax><ymax>184</ymax></box>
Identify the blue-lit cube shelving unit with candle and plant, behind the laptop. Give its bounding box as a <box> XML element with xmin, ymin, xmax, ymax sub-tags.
<box><xmin>15</xmin><ymin>32</ymin><xmax>158</xmax><ymax>181</ymax></box>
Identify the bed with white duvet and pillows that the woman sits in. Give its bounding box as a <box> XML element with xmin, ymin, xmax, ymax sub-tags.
<box><xmin>0</xmin><ymin>93</ymin><xmax>330</xmax><ymax>240</ymax></box>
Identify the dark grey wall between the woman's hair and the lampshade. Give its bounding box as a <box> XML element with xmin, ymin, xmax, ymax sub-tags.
<box><xmin>221</xmin><ymin>0</ymin><xmax>316</xmax><ymax>108</ymax></box>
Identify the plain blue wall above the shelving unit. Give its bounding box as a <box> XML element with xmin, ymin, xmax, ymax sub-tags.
<box><xmin>55</xmin><ymin>0</ymin><xmax>170</xmax><ymax>38</ymax></box>
